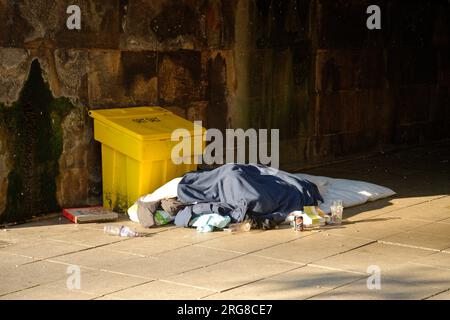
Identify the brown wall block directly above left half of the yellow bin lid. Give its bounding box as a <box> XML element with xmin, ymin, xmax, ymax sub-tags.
<box><xmin>89</xmin><ymin>51</ymin><xmax>158</xmax><ymax>108</ymax></box>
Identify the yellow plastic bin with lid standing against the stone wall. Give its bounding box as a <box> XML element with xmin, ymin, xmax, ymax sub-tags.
<box><xmin>89</xmin><ymin>107</ymin><xmax>204</xmax><ymax>213</ymax></box>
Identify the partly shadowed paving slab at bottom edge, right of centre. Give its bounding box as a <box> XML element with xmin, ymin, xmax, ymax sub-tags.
<box><xmin>202</xmin><ymin>266</ymin><xmax>361</xmax><ymax>300</ymax></box>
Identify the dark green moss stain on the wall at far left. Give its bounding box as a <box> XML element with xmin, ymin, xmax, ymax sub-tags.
<box><xmin>0</xmin><ymin>60</ymin><xmax>74</xmax><ymax>223</ymax></box>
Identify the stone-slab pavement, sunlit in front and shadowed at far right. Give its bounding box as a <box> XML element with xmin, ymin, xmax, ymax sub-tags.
<box><xmin>0</xmin><ymin>142</ymin><xmax>450</xmax><ymax>300</ymax></box>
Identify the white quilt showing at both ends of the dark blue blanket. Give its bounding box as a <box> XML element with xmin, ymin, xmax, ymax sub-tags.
<box><xmin>128</xmin><ymin>173</ymin><xmax>395</xmax><ymax>222</ymax></box>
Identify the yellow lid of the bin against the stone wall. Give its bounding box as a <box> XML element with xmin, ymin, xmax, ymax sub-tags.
<box><xmin>89</xmin><ymin>107</ymin><xmax>204</xmax><ymax>140</ymax></box>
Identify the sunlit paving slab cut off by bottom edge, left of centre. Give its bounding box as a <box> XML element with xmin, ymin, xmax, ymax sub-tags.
<box><xmin>102</xmin><ymin>281</ymin><xmax>212</xmax><ymax>300</ymax></box>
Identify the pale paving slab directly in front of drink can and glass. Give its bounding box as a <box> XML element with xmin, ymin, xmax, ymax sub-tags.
<box><xmin>252</xmin><ymin>232</ymin><xmax>371</xmax><ymax>264</ymax></box>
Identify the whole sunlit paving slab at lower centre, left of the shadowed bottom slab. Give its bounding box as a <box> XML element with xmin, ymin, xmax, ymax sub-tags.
<box><xmin>164</xmin><ymin>255</ymin><xmax>301</xmax><ymax>292</ymax></box>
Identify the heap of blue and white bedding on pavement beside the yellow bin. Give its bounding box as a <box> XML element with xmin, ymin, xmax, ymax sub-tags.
<box><xmin>128</xmin><ymin>164</ymin><xmax>395</xmax><ymax>232</ymax></box>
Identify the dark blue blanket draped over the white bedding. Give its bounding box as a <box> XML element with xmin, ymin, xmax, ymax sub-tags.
<box><xmin>175</xmin><ymin>164</ymin><xmax>323</xmax><ymax>227</ymax></box>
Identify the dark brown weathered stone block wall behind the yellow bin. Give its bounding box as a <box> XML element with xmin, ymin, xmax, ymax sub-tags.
<box><xmin>0</xmin><ymin>0</ymin><xmax>450</xmax><ymax>220</ymax></box>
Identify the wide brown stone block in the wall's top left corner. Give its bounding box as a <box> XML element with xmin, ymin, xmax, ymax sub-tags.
<box><xmin>0</xmin><ymin>0</ymin><xmax>120</xmax><ymax>48</ymax></box>
